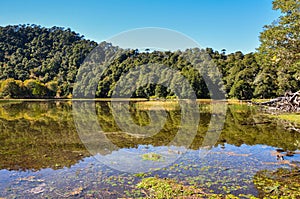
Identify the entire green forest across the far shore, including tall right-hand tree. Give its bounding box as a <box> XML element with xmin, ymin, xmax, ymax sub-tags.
<box><xmin>0</xmin><ymin>0</ymin><xmax>300</xmax><ymax>100</ymax></box>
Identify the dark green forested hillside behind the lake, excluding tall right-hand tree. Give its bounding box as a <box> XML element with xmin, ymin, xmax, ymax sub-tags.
<box><xmin>0</xmin><ymin>25</ymin><xmax>259</xmax><ymax>99</ymax></box>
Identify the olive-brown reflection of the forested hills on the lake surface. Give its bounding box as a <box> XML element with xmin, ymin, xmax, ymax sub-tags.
<box><xmin>0</xmin><ymin>101</ymin><xmax>300</xmax><ymax>170</ymax></box>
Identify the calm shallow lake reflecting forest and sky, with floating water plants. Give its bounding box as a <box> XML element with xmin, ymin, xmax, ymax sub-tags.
<box><xmin>0</xmin><ymin>100</ymin><xmax>300</xmax><ymax>198</ymax></box>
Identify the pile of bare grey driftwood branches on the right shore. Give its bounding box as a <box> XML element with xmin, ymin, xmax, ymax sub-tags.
<box><xmin>254</xmin><ymin>91</ymin><xmax>300</xmax><ymax>112</ymax></box>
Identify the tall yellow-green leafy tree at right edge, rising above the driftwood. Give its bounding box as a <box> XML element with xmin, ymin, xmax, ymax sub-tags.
<box><xmin>256</xmin><ymin>0</ymin><xmax>300</xmax><ymax>95</ymax></box>
